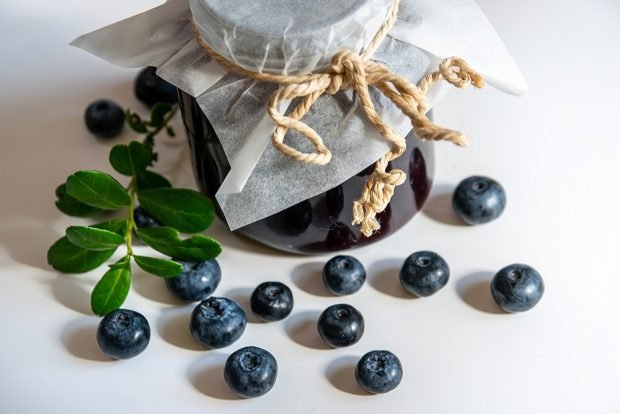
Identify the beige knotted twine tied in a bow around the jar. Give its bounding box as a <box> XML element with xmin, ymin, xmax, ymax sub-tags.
<box><xmin>191</xmin><ymin>0</ymin><xmax>484</xmax><ymax>237</ymax></box>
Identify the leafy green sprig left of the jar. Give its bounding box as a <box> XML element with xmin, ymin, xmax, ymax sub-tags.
<box><xmin>47</xmin><ymin>103</ymin><xmax>221</xmax><ymax>315</ymax></box>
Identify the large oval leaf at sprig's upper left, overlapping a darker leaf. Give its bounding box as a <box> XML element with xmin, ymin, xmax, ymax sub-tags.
<box><xmin>67</xmin><ymin>170</ymin><xmax>131</xmax><ymax>210</ymax></box>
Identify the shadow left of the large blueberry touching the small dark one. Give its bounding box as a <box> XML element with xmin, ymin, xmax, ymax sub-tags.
<box><xmin>157</xmin><ymin>304</ymin><xmax>208</xmax><ymax>351</ymax></box>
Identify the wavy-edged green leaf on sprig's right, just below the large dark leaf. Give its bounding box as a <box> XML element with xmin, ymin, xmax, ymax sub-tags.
<box><xmin>136</xmin><ymin>227</ymin><xmax>222</xmax><ymax>261</ymax></box>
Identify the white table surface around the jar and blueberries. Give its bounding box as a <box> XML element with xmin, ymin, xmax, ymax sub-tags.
<box><xmin>0</xmin><ymin>0</ymin><xmax>620</xmax><ymax>414</ymax></box>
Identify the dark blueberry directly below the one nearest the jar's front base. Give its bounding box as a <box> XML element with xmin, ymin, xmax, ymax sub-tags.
<box><xmin>317</xmin><ymin>304</ymin><xmax>364</xmax><ymax>348</ymax></box>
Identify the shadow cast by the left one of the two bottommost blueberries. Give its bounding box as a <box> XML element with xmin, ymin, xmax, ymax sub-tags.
<box><xmin>187</xmin><ymin>352</ymin><xmax>241</xmax><ymax>400</ymax></box>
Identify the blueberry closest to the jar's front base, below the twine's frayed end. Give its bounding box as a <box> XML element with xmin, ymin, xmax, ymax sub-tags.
<box><xmin>323</xmin><ymin>255</ymin><xmax>366</xmax><ymax>295</ymax></box>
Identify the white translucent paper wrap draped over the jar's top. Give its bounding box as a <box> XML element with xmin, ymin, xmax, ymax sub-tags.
<box><xmin>72</xmin><ymin>0</ymin><xmax>527</xmax><ymax>230</ymax></box>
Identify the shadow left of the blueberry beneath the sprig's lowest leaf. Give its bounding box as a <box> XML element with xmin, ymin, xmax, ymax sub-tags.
<box><xmin>60</xmin><ymin>316</ymin><xmax>114</xmax><ymax>362</ymax></box>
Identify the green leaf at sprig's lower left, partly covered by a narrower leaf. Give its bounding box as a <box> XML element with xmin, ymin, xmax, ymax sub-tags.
<box><xmin>47</xmin><ymin>237</ymin><xmax>116</xmax><ymax>273</ymax></box>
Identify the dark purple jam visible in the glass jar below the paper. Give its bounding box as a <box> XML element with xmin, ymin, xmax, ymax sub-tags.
<box><xmin>179</xmin><ymin>91</ymin><xmax>434</xmax><ymax>254</ymax></box>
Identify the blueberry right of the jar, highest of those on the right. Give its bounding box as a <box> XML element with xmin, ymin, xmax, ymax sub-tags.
<box><xmin>452</xmin><ymin>176</ymin><xmax>506</xmax><ymax>225</ymax></box>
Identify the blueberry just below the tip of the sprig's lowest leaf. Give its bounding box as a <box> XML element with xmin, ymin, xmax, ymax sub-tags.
<box><xmin>97</xmin><ymin>309</ymin><xmax>151</xmax><ymax>359</ymax></box>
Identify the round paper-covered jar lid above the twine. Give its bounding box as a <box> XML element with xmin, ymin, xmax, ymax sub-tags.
<box><xmin>189</xmin><ymin>0</ymin><xmax>392</xmax><ymax>75</ymax></box>
